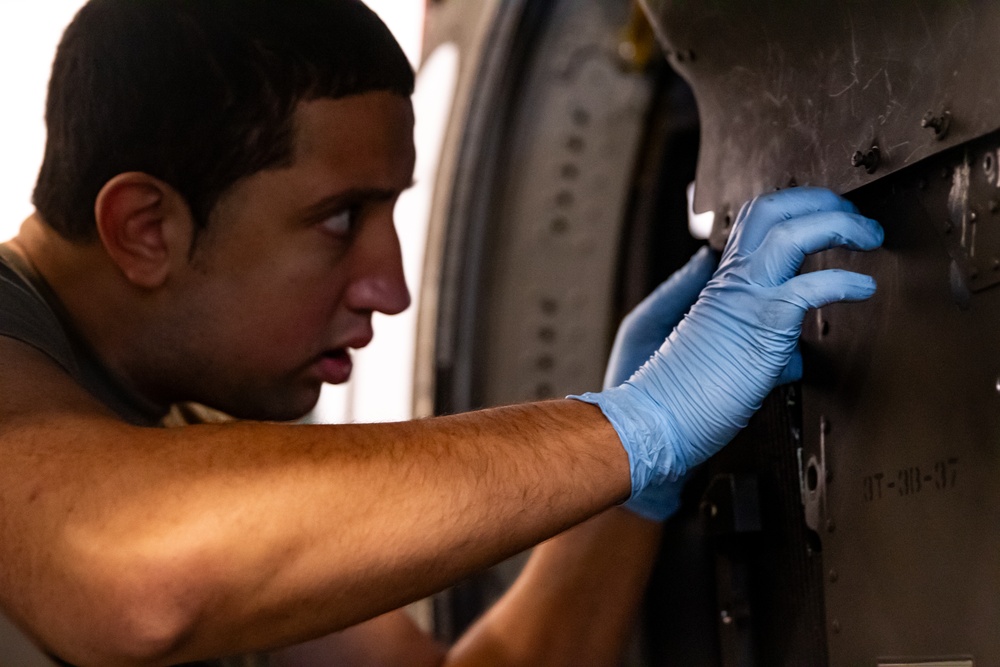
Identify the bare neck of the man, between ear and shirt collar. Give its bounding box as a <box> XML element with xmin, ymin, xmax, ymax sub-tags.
<box><xmin>8</xmin><ymin>214</ymin><xmax>169</xmax><ymax>410</ymax></box>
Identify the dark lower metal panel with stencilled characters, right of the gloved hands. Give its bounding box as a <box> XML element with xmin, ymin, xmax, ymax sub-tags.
<box><xmin>803</xmin><ymin>129</ymin><xmax>1000</xmax><ymax>667</ymax></box>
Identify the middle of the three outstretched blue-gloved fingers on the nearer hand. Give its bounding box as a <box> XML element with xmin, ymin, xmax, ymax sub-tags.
<box><xmin>746</xmin><ymin>212</ymin><xmax>885</xmax><ymax>286</ymax></box>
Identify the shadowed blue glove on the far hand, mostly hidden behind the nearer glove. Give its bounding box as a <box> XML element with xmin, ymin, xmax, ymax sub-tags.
<box><xmin>604</xmin><ymin>247</ymin><xmax>718</xmax><ymax>521</ymax></box>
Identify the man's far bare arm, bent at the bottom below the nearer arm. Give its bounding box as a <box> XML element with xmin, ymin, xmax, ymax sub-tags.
<box><xmin>271</xmin><ymin>508</ymin><xmax>660</xmax><ymax>667</ymax></box>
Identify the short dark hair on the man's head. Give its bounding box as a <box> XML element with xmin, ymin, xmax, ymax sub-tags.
<box><xmin>33</xmin><ymin>0</ymin><xmax>414</xmax><ymax>241</ymax></box>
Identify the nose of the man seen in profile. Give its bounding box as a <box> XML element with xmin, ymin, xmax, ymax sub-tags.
<box><xmin>346</xmin><ymin>217</ymin><xmax>411</xmax><ymax>315</ymax></box>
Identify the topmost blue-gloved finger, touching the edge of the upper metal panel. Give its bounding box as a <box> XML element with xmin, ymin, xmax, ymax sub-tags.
<box><xmin>723</xmin><ymin>187</ymin><xmax>858</xmax><ymax>261</ymax></box>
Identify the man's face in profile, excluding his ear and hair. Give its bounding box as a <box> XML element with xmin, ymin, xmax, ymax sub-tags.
<box><xmin>151</xmin><ymin>92</ymin><xmax>414</xmax><ymax>420</ymax></box>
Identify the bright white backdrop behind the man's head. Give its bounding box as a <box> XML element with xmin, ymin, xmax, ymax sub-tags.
<box><xmin>0</xmin><ymin>0</ymin><xmax>458</xmax><ymax>421</ymax></box>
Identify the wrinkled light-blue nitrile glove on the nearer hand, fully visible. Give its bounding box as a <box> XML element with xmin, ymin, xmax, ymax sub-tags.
<box><xmin>577</xmin><ymin>188</ymin><xmax>883</xmax><ymax>497</ymax></box>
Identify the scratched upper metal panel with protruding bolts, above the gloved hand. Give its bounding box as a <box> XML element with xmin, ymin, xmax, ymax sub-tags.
<box><xmin>641</xmin><ymin>0</ymin><xmax>1000</xmax><ymax>232</ymax></box>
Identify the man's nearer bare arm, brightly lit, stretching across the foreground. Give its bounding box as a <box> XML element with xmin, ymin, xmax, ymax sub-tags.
<box><xmin>0</xmin><ymin>340</ymin><xmax>629</xmax><ymax>665</ymax></box>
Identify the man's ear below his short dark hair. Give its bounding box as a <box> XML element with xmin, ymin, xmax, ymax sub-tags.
<box><xmin>94</xmin><ymin>172</ymin><xmax>194</xmax><ymax>289</ymax></box>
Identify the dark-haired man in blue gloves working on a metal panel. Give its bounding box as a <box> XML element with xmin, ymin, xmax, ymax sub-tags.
<box><xmin>0</xmin><ymin>0</ymin><xmax>882</xmax><ymax>666</ymax></box>
